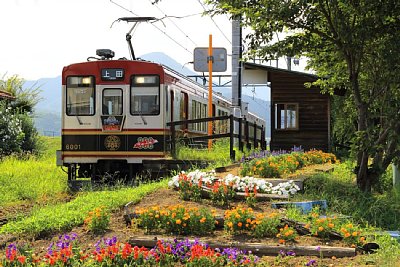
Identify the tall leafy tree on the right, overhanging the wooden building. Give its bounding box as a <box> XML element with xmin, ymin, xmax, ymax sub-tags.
<box><xmin>207</xmin><ymin>0</ymin><xmax>400</xmax><ymax>191</ymax></box>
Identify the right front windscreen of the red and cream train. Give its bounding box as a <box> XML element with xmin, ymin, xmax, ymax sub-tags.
<box><xmin>130</xmin><ymin>75</ymin><xmax>160</xmax><ymax>115</ymax></box>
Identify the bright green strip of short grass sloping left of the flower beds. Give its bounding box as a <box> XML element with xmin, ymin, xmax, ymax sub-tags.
<box><xmin>0</xmin><ymin>180</ymin><xmax>167</xmax><ymax>237</ymax></box>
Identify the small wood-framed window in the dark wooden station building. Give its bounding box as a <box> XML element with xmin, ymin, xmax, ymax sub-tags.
<box><xmin>275</xmin><ymin>103</ymin><xmax>299</xmax><ymax>130</ymax></box>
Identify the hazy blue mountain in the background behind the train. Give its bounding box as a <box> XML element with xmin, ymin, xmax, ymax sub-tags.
<box><xmin>28</xmin><ymin>52</ymin><xmax>270</xmax><ymax>137</ymax></box>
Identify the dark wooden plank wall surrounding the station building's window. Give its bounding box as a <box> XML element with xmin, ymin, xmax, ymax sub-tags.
<box><xmin>268</xmin><ymin>72</ymin><xmax>329</xmax><ymax>151</ymax></box>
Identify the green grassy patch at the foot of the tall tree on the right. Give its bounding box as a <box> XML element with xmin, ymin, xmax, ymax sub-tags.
<box><xmin>295</xmin><ymin>162</ymin><xmax>400</xmax><ymax>229</ymax></box>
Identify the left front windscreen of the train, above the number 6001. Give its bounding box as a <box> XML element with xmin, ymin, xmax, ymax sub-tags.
<box><xmin>66</xmin><ymin>76</ymin><xmax>95</xmax><ymax>116</ymax></box>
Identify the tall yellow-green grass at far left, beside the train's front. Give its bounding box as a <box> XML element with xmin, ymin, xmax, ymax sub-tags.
<box><xmin>0</xmin><ymin>137</ymin><xmax>67</xmax><ymax>207</ymax></box>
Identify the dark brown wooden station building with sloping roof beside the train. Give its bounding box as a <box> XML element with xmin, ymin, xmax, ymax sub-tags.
<box><xmin>243</xmin><ymin>63</ymin><xmax>330</xmax><ymax>151</ymax></box>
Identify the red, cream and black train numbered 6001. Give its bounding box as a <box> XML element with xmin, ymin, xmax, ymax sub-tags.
<box><xmin>57</xmin><ymin>49</ymin><xmax>265</xmax><ymax>180</ymax></box>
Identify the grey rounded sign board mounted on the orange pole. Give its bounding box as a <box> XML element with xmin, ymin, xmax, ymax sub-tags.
<box><xmin>193</xmin><ymin>47</ymin><xmax>227</xmax><ymax>72</ymax></box>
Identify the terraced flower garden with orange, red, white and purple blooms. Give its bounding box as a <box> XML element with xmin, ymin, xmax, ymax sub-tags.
<box><xmin>0</xmin><ymin>151</ymin><xmax>390</xmax><ymax>266</ymax></box>
